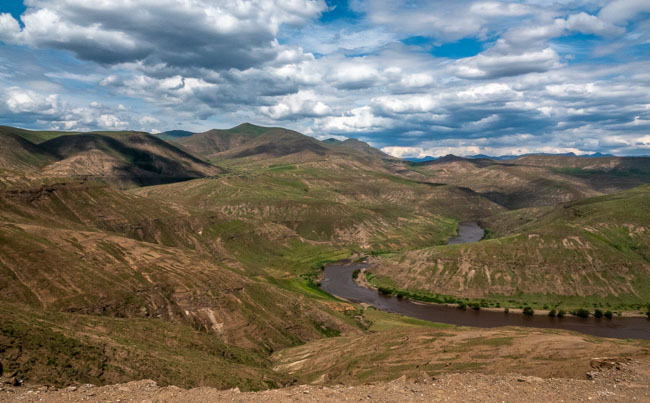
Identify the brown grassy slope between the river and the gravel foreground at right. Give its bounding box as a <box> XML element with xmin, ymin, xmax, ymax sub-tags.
<box><xmin>273</xmin><ymin>308</ymin><xmax>648</xmax><ymax>385</ymax></box>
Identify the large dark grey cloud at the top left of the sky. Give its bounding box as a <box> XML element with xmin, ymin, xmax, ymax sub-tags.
<box><xmin>0</xmin><ymin>0</ymin><xmax>325</xmax><ymax>70</ymax></box>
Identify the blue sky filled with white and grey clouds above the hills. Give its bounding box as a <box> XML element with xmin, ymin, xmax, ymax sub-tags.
<box><xmin>0</xmin><ymin>0</ymin><xmax>650</xmax><ymax>158</ymax></box>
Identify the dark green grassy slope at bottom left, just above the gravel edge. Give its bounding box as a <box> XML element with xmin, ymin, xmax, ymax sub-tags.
<box><xmin>0</xmin><ymin>304</ymin><xmax>287</xmax><ymax>390</ymax></box>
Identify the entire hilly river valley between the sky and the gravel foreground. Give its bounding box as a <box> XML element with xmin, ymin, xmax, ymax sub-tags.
<box><xmin>0</xmin><ymin>124</ymin><xmax>650</xmax><ymax>391</ymax></box>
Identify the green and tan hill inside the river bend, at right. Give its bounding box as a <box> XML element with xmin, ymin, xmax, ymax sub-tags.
<box><xmin>372</xmin><ymin>185</ymin><xmax>650</xmax><ymax>304</ymax></box>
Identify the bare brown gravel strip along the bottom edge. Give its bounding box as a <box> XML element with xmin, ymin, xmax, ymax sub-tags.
<box><xmin>0</xmin><ymin>359</ymin><xmax>650</xmax><ymax>402</ymax></box>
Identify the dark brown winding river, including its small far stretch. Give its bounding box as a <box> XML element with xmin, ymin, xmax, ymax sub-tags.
<box><xmin>321</xmin><ymin>223</ymin><xmax>650</xmax><ymax>340</ymax></box>
